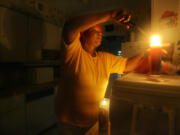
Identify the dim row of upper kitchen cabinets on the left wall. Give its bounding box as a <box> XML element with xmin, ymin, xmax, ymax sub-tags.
<box><xmin>0</xmin><ymin>7</ymin><xmax>61</xmax><ymax>62</ymax></box>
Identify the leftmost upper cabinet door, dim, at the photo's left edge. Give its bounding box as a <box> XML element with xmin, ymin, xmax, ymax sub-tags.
<box><xmin>0</xmin><ymin>7</ymin><xmax>28</xmax><ymax>62</ymax></box>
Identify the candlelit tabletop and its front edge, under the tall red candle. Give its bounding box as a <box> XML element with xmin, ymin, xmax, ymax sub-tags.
<box><xmin>113</xmin><ymin>73</ymin><xmax>180</xmax><ymax>98</ymax></box>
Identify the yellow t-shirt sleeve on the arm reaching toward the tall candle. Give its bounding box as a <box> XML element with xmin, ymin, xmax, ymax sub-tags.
<box><xmin>107</xmin><ymin>54</ymin><xmax>127</xmax><ymax>74</ymax></box>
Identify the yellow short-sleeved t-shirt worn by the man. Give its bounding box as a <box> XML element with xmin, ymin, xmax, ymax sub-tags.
<box><xmin>56</xmin><ymin>35</ymin><xmax>127</xmax><ymax>127</ymax></box>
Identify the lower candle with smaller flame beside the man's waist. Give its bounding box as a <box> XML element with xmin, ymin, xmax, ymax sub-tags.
<box><xmin>99</xmin><ymin>98</ymin><xmax>110</xmax><ymax>135</ymax></box>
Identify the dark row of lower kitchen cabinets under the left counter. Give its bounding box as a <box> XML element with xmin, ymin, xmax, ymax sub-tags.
<box><xmin>0</xmin><ymin>87</ymin><xmax>56</xmax><ymax>135</ymax></box>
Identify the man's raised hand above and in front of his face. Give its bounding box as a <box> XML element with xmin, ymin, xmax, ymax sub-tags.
<box><xmin>111</xmin><ymin>9</ymin><xmax>131</xmax><ymax>29</ymax></box>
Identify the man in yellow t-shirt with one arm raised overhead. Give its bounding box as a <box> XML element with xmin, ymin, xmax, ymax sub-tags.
<box><xmin>55</xmin><ymin>9</ymin><xmax>144</xmax><ymax>135</ymax></box>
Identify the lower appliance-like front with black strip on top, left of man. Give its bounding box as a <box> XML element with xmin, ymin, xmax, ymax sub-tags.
<box><xmin>27</xmin><ymin>89</ymin><xmax>55</xmax><ymax>135</ymax></box>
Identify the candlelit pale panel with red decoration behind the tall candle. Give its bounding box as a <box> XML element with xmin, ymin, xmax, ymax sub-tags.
<box><xmin>151</xmin><ymin>0</ymin><xmax>180</xmax><ymax>42</ymax></box>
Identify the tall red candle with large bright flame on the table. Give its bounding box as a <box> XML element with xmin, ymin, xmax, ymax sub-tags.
<box><xmin>149</xmin><ymin>35</ymin><xmax>162</xmax><ymax>74</ymax></box>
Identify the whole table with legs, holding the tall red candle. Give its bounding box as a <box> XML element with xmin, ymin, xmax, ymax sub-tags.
<box><xmin>111</xmin><ymin>73</ymin><xmax>180</xmax><ymax>135</ymax></box>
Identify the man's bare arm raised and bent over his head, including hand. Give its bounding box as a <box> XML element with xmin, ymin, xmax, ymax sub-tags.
<box><xmin>63</xmin><ymin>9</ymin><xmax>130</xmax><ymax>44</ymax></box>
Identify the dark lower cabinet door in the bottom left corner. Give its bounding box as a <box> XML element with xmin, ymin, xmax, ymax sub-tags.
<box><xmin>0</xmin><ymin>95</ymin><xmax>26</xmax><ymax>135</ymax></box>
